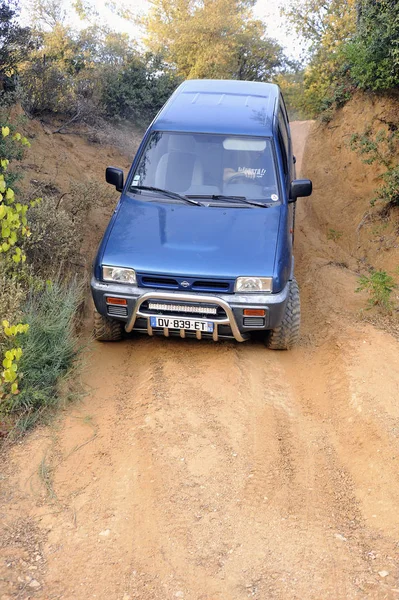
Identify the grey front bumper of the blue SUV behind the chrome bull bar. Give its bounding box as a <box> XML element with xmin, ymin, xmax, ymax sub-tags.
<box><xmin>91</xmin><ymin>278</ymin><xmax>290</xmax><ymax>342</ymax></box>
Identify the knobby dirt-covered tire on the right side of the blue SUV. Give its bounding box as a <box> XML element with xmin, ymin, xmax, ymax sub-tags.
<box><xmin>266</xmin><ymin>277</ymin><xmax>301</xmax><ymax>350</ymax></box>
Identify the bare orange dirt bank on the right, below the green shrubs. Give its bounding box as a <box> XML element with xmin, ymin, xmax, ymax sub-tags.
<box><xmin>305</xmin><ymin>94</ymin><xmax>399</xmax><ymax>279</ymax></box>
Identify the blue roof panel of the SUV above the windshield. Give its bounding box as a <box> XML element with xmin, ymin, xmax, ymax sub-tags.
<box><xmin>152</xmin><ymin>79</ymin><xmax>280</xmax><ymax>137</ymax></box>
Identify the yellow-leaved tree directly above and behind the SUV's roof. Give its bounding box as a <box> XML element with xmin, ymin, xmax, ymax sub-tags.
<box><xmin>144</xmin><ymin>0</ymin><xmax>284</xmax><ymax>80</ymax></box>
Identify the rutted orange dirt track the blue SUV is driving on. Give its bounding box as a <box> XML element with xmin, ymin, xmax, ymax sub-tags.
<box><xmin>0</xmin><ymin>123</ymin><xmax>399</xmax><ymax>600</ymax></box>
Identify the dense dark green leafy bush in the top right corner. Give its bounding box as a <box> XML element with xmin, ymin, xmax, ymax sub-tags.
<box><xmin>344</xmin><ymin>0</ymin><xmax>399</xmax><ymax>91</ymax></box>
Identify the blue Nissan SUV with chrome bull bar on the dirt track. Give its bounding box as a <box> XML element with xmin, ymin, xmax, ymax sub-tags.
<box><xmin>91</xmin><ymin>80</ymin><xmax>312</xmax><ymax>350</ymax></box>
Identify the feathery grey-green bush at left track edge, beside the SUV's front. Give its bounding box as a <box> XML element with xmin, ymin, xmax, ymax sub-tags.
<box><xmin>1</xmin><ymin>279</ymin><xmax>82</xmax><ymax>426</ymax></box>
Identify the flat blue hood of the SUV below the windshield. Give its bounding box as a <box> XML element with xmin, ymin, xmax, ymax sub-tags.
<box><xmin>102</xmin><ymin>196</ymin><xmax>283</xmax><ymax>278</ymax></box>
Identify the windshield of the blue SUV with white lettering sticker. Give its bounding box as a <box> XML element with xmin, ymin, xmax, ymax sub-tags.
<box><xmin>131</xmin><ymin>132</ymin><xmax>279</xmax><ymax>204</ymax></box>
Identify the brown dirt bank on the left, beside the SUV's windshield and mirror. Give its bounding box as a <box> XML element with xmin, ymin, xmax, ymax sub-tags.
<box><xmin>13</xmin><ymin>111</ymin><xmax>140</xmax><ymax>269</ymax></box>
